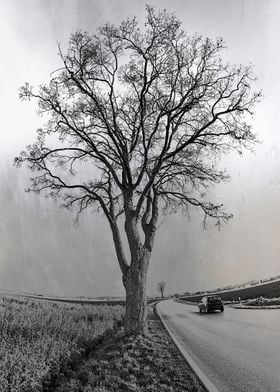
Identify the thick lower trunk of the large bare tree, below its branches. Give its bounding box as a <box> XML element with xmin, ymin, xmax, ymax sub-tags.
<box><xmin>123</xmin><ymin>251</ymin><xmax>150</xmax><ymax>335</ymax></box>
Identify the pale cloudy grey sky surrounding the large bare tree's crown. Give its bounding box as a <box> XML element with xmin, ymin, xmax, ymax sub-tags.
<box><xmin>0</xmin><ymin>0</ymin><xmax>280</xmax><ymax>296</ymax></box>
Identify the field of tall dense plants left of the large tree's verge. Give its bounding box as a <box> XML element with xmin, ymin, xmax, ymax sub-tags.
<box><xmin>0</xmin><ymin>295</ymin><xmax>124</xmax><ymax>392</ymax></box>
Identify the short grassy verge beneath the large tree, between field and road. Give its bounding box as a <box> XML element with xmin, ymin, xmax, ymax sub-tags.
<box><xmin>55</xmin><ymin>312</ymin><xmax>205</xmax><ymax>392</ymax></box>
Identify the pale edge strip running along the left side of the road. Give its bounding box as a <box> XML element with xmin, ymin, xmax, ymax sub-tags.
<box><xmin>156</xmin><ymin>305</ymin><xmax>220</xmax><ymax>392</ymax></box>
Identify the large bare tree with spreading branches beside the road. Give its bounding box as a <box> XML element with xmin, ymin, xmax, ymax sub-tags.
<box><xmin>15</xmin><ymin>7</ymin><xmax>260</xmax><ymax>333</ymax></box>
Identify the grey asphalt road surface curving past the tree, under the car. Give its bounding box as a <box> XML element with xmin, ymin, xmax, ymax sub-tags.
<box><xmin>157</xmin><ymin>300</ymin><xmax>280</xmax><ymax>392</ymax></box>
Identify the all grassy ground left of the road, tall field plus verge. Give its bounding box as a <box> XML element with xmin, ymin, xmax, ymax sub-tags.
<box><xmin>0</xmin><ymin>295</ymin><xmax>205</xmax><ymax>392</ymax></box>
